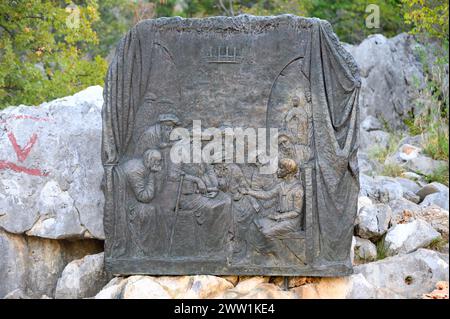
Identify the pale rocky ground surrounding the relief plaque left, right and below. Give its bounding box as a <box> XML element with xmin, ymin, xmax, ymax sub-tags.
<box><xmin>0</xmin><ymin>34</ymin><xmax>449</xmax><ymax>298</ymax></box>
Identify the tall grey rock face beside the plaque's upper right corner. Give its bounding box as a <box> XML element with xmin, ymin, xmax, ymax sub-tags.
<box><xmin>346</xmin><ymin>33</ymin><xmax>424</xmax><ymax>128</ymax></box>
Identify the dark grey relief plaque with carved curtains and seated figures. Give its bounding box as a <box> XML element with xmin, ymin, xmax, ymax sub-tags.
<box><xmin>102</xmin><ymin>15</ymin><xmax>360</xmax><ymax>276</ymax></box>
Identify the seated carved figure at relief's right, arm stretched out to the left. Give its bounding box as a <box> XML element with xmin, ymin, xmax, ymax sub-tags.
<box><xmin>240</xmin><ymin>158</ymin><xmax>303</xmax><ymax>238</ymax></box>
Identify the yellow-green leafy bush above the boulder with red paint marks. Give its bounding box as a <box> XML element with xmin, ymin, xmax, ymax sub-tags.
<box><xmin>0</xmin><ymin>0</ymin><xmax>107</xmax><ymax>108</ymax></box>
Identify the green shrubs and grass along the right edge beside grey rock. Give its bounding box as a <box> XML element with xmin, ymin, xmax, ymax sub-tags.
<box><xmin>402</xmin><ymin>6</ymin><xmax>449</xmax><ymax>178</ymax></box>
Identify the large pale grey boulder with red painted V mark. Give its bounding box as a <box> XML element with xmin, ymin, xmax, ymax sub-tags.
<box><xmin>0</xmin><ymin>86</ymin><xmax>104</xmax><ymax>239</ymax></box>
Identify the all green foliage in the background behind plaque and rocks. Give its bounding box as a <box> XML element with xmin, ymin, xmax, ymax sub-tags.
<box><xmin>0</xmin><ymin>0</ymin><xmax>448</xmax><ymax>111</ymax></box>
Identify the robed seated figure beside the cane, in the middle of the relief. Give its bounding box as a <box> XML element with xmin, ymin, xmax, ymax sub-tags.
<box><xmin>170</xmin><ymin>163</ymin><xmax>231</xmax><ymax>259</ymax></box>
